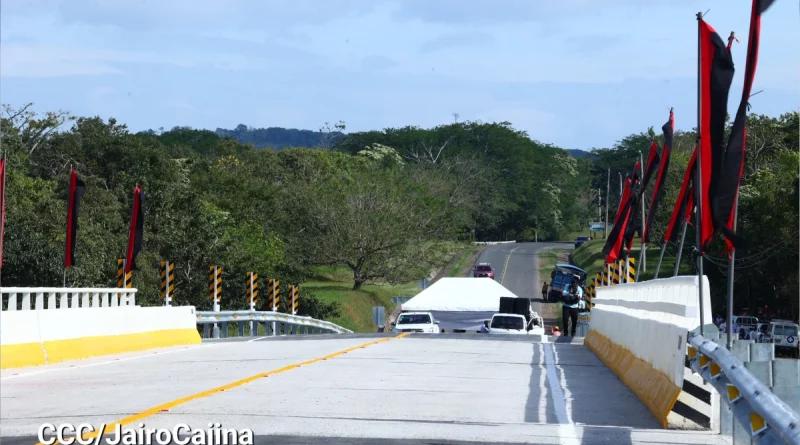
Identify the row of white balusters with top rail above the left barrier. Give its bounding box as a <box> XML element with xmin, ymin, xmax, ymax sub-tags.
<box><xmin>0</xmin><ymin>287</ymin><xmax>136</xmax><ymax>311</ymax></box>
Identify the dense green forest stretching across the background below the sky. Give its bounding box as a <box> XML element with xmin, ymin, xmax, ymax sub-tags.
<box><xmin>0</xmin><ymin>101</ymin><xmax>800</xmax><ymax>318</ymax></box>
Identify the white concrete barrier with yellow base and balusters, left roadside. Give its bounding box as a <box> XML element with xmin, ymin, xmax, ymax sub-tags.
<box><xmin>0</xmin><ymin>288</ymin><xmax>200</xmax><ymax>369</ymax></box>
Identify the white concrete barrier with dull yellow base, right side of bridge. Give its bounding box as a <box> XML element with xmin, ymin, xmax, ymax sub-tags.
<box><xmin>585</xmin><ymin>276</ymin><xmax>712</xmax><ymax>428</ymax></box>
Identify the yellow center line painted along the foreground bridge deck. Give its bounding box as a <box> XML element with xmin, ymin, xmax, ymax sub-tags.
<box><xmin>36</xmin><ymin>332</ymin><xmax>409</xmax><ymax>445</ymax></box>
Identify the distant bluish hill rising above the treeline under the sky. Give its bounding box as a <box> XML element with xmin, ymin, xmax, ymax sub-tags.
<box><xmin>214</xmin><ymin>124</ymin><xmax>344</xmax><ymax>149</ymax></box>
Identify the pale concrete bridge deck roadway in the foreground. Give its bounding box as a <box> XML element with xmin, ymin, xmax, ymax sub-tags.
<box><xmin>0</xmin><ymin>334</ymin><xmax>719</xmax><ymax>445</ymax></box>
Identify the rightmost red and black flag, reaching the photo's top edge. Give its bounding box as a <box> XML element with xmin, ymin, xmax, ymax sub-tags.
<box><xmin>704</xmin><ymin>0</ymin><xmax>773</xmax><ymax>252</ymax></box>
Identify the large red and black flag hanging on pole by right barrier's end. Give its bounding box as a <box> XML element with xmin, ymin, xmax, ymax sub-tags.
<box><xmin>694</xmin><ymin>19</ymin><xmax>734</xmax><ymax>252</ymax></box>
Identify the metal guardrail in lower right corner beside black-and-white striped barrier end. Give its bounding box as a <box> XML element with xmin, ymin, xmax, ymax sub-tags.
<box><xmin>689</xmin><ymin>333</ymin><xmax>800</xmax><ymax>445</ymax></box>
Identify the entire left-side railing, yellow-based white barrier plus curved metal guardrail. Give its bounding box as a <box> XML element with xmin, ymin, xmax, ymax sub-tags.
<box><xmin>0</xmin><ymin>287</ymin><xmax>352</xmax><ymax>369</ymax></box>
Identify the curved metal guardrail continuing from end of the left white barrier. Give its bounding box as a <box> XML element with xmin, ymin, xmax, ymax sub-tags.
<box><xmin>196</xmin><ymin>311</ymin><xmax>353</xmax><ymax>338</ymax></box>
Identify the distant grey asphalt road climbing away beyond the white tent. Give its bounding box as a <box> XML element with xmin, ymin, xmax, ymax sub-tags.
<box><xmin>478</xmin><ymin>242</ymin><xmax>574</xmax><ymax>329</ymax></box>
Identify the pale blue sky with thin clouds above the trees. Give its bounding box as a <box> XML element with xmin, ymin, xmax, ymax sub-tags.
<box><xmin>0</xmin><ymin>0</ymin><xmax>800</xmax><ymax>150</ymax></box>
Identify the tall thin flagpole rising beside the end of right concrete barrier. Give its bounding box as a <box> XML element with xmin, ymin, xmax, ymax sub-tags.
<box><xmin>692</xmin><ymin>12</ymin><xmax>705</xmax><ymax>336</ymax></box>
